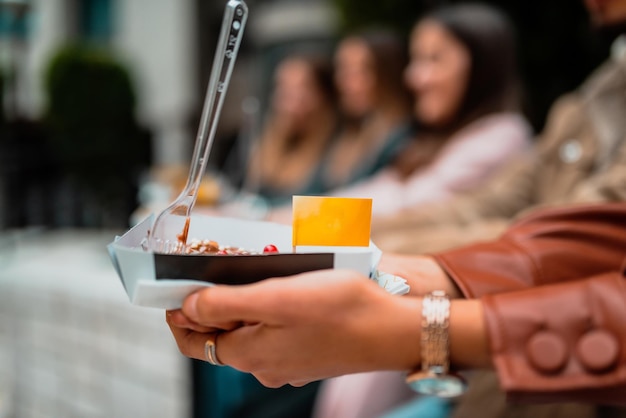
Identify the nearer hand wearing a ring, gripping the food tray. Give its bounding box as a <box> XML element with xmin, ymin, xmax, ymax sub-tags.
<box><xmin>167</xmin><ymin>270</ymin><xmax>421</xmax><ymax>387</ymax></box>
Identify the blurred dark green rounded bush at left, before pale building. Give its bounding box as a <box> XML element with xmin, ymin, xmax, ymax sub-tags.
<box><xmin>44</xmin><ymin>44</ymin><xmax>151</xmax><ymax>222</ymax></box>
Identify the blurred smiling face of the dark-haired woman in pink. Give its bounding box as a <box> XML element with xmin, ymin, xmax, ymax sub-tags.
<box><xmin>405</xmin><ymin>21</ymin><xmax>471</xmax><ymax>126</ymax></box>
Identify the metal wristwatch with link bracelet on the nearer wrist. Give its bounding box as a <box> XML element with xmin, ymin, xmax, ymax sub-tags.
<box><xmin>406</xmin><ymin>290</ymin><xmax>467</xmax><ymax>398</ymax></box>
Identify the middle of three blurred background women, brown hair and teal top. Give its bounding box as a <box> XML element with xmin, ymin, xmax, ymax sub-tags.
<box><xmin>304</xmin><ymin>29</ymin><xmax>410</xmax><ymax>193</ymax></box>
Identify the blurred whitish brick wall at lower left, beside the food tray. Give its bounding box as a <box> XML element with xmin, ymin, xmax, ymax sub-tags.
<box><xmin>0</xmin><ymin>232</ymin><xmax>191</xmax><ymax>418</ymax></box>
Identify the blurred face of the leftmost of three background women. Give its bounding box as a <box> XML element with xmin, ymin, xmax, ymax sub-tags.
<box><xmin>272</xmin><ymin>59</ymin><xmax>325</xmax><ymax>125</ymax></box>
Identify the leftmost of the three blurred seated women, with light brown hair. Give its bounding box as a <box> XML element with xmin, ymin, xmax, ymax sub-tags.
<box><xmin>245</xmin><ymin>55</ymin><xmax>337</xmax><ymax>206</ymax></box>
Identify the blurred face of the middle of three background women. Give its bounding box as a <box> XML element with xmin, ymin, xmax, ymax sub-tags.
<box><xmin>335</xmin><ymin>39</ymin><xmax>376</xmax><ymax>117</ymax></box>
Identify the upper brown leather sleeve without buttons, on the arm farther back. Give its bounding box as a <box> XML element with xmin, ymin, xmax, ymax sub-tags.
<box><xmin>433</xmin><ymin>203</ymin><xmax>626</xmax><ymax>298</ymax></box>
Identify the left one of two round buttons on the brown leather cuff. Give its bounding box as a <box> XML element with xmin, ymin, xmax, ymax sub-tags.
<box><xmin>526</xmin><ymin>331</ymin><xmax>569</xmax><ymax>374</ymax></box>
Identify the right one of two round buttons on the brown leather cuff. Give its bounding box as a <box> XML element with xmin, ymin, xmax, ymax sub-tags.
<box><xmin>576</xmin><ymin>330</ymin><xmax>620</xmax><ymax>373</ymax></box>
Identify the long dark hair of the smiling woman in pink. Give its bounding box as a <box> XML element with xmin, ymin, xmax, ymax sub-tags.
<box><xmin>418</xmin><ymin>3</ymin><xmax>521</xmax><ymax>124</ymax></box>
